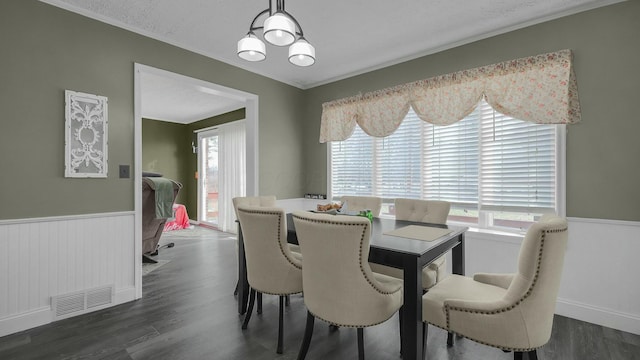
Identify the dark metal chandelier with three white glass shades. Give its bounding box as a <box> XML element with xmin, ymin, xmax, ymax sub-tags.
<box><xmin>238</xmin><ymin>0</ymin><xmax>316</xmax><ymax>66</ymax></box>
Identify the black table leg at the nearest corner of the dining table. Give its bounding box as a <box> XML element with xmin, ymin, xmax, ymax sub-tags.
<box><xmin>401</xmin><ymin>257</ymin><xmax>424</xmax><ymax>360</ymax></box>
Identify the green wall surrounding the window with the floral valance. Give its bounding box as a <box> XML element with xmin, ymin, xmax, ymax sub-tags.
<box><xmin>303</xmin><ymin>1</ymin><xmax>640</xmax><ymax>221</ymax></box>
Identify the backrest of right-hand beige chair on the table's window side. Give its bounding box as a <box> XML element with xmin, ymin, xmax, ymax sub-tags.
<box><xmin>395</xmin><ymin>198</ymin><xmax>451</xmax><ymax>224</ymax></box>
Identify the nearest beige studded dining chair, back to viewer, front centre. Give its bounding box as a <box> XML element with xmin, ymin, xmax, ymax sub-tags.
<box><xmin>293</xmin><ymin>211</ymin><xmax>402</xmax><ymax>359</ymax></box>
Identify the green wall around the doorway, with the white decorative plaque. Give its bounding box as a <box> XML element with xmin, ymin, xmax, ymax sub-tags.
<box><xmin>0</xmin><ymin>0</ymin><xmax>305</xmax><ymax>219</ymax></box>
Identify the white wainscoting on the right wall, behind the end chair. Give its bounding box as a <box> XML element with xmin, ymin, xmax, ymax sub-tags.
<box><xmin>458</xmin><ymin>218</ymin><xmax>640</xmax><ymax>334</ymax></box>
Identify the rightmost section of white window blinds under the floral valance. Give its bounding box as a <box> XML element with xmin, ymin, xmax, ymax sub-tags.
<box><xmin>476</xmin><ymin>102</ymin><xmax>556</xmax><ymax>213</ymax></box>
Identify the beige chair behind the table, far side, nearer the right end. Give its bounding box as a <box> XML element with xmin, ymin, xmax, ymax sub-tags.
<box><xmin>371</xmin><ymin>198</ymin><xmax>451</xmax><ymax>290</ymax></box>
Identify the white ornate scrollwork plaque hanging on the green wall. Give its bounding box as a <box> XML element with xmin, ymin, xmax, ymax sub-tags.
<box><xmin>64</xmin><ymin>90</ymin><xmax>107</xmax><ymax>178</ymax></box>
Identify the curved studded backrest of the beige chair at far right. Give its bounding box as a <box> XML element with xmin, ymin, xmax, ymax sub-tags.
<box><xmin>503</xmin><ymin>215</ymin><xmax>568</xmax><ymax>348</ymax></box>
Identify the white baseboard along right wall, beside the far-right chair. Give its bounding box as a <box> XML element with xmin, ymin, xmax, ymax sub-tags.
<box><xmin>556</xmin><ymin>298</ymin><xmax>640</xmax><ymax>335</ymax></box>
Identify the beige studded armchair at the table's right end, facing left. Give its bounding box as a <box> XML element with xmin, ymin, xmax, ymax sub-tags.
<box><xmin>422</xmin><ymin>215</ymin><xmax>567</xmax><ymax>359</ymax></box>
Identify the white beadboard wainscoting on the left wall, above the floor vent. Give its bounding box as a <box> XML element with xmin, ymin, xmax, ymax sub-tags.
<box><xmin>0</xmin><ymin>212</ymin><xmax>135</xmax><ymax>336</ymax></box>
